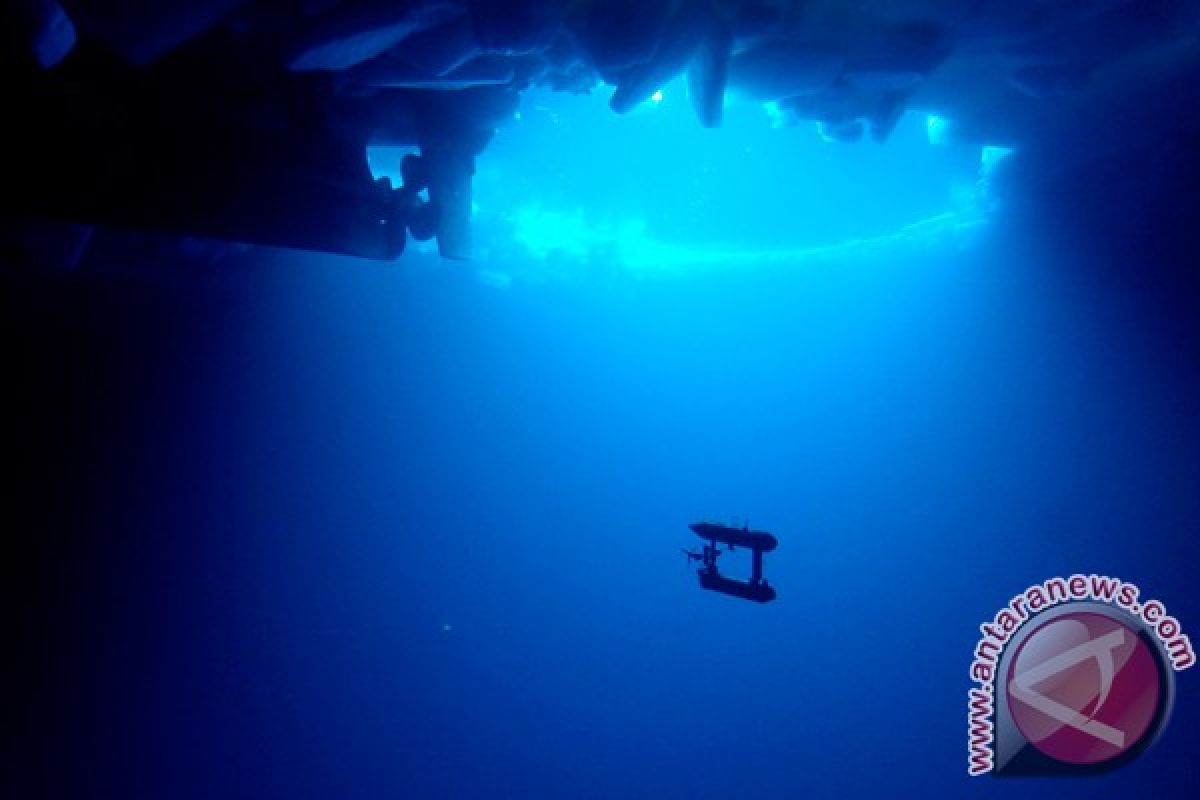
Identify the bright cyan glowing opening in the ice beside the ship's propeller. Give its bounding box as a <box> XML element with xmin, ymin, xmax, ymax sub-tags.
<box><xmin>473</xmin><ymin>84</ymin><xmax>990</xmax><ymax>288</ymax></box>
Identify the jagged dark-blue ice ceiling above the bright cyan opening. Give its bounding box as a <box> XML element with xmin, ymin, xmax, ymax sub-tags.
<box><xmin>283</xmin><ymin>0</ymin><xmax>1200</xmax><ymax>158</ymax></box>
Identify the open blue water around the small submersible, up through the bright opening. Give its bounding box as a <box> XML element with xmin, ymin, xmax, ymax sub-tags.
<box><xmin>6</xmin><ymin>86</ymin><xmax>1200</xmax><ymax>800</ymax></box>
